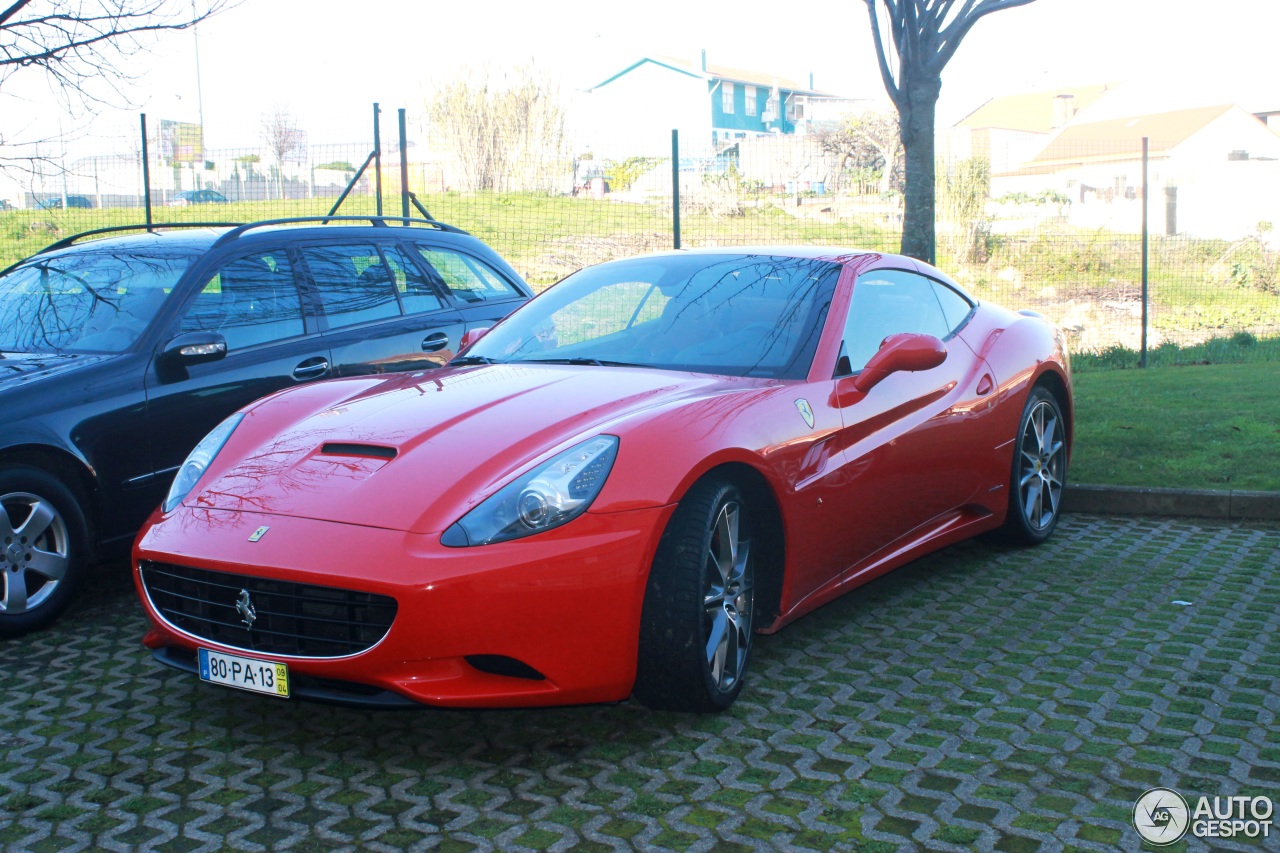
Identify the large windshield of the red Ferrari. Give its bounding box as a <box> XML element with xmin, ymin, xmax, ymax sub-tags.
<box><xmin>467</xmin><ymin>254</ymin><xmax>840</xmax><ymax>379</ymax></box>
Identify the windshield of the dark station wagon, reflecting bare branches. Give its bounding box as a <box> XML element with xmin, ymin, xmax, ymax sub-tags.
<box><xmin>0</xmin><ymin>250</ymin><xmax>197</xmax><ymax>352</ymax></box>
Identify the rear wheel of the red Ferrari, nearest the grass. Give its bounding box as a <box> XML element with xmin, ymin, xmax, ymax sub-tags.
<box><xmin>1000</xmin><ymin>386</ymin><xmax>1066</xmax><ymax>546</ymax></box>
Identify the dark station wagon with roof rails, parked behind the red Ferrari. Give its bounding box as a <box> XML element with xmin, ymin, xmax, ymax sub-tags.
<box><xmin>0</xmin><ymin>216</ymin><xmax>530</xmax><ymax>637</ymax></box>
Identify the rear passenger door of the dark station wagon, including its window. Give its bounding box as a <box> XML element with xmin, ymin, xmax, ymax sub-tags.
<box><xmin>301</xmin><ymin>240</ymin><xmax>465</xmax><ymax>377</ymax></box>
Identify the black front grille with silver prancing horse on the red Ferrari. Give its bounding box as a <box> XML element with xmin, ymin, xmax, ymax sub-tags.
<box><xmin>141</xmin><ymin>561</ymin><xmax>396</xmax><ymax>657</ymax></box>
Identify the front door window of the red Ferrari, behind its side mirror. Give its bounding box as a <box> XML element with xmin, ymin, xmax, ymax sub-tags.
<box><xmin>836</xmin><ymin>269</ymin><xmax>952</xmax><ymax>374</ymax></box>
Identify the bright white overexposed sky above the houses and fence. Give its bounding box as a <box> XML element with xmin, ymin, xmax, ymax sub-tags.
<box><xmin>0</xmin><ymin>0</ymin><xmax>1280</xmax><ymax>152</ymax></box>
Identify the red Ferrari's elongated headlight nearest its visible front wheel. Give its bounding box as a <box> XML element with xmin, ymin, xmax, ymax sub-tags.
<box><xmin>440</xmin><ymin>435</ymin><xmax>618</xmax><ymax>548</ymax></box>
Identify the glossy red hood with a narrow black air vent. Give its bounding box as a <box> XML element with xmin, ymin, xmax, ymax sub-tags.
<box><xmin>184</xmin><ymin>365</ymin><xmax>757</xmax><ymax>533</ymax></box>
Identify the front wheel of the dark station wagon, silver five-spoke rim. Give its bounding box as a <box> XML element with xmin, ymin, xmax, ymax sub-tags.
<box><xmin>0</xmin><ymin>466</ymin><xmax>91</xmax><ymax>637</ymax></box>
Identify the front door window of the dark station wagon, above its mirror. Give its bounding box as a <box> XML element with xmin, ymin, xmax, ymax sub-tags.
<box><xmin>179</xmin><ymin>248</ymin><xmax>306</xmax><ymax>352</ymax></box>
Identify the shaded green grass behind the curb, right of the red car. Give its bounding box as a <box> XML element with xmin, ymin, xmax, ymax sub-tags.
<box><xmin>1070</xmin><ymin>362</ymin><xmax>1280</xmax><ymax>492</ymax></box>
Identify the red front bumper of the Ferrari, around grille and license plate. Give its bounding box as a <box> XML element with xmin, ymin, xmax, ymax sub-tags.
<box><xmin>133</xmin><ymin>506</ymin><xmax>675</xmax><ymax>707</ymax></box>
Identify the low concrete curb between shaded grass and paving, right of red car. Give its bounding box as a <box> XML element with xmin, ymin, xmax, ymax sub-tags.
<box><xmin>1062</xmin><ymin>484</ymin><xmax>1280</xmax><ymax>521</ymax></box>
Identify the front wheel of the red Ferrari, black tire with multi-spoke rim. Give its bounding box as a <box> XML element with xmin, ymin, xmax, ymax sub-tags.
<box><xmin>635</xmin><ymin>479</ymin><xmax>755</xmax><ymax>713</ymax></box>
